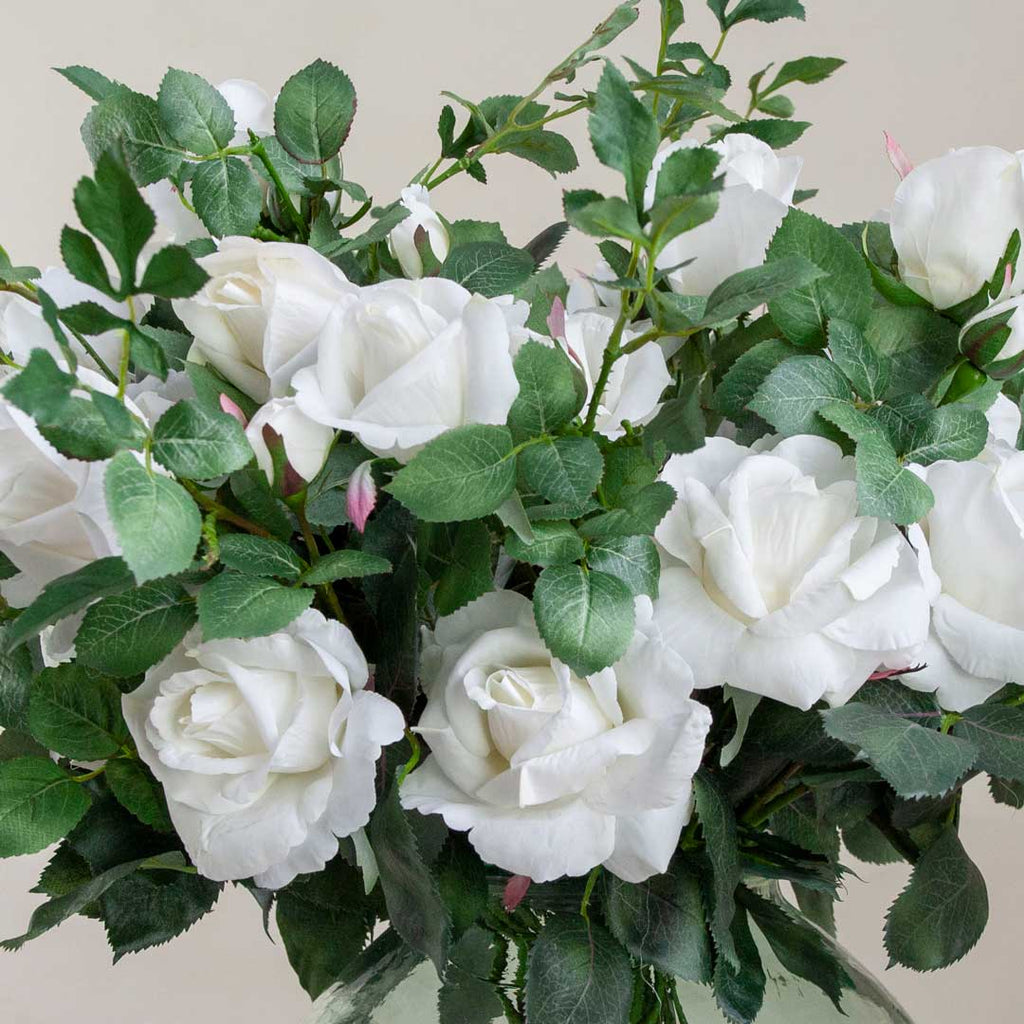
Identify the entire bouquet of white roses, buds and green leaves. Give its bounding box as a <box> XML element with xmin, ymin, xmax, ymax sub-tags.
<box><xmin>0</xmin><ymin>0</ymin><xmax>1024</xmax><ymax>1024</ymax></box>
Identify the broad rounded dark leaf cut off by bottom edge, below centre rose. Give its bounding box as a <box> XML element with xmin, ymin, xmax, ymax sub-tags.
<box><xmin>526</xmin><ymin>914</ymin><xmax>633</xmax><ymax>1024</ymax></box>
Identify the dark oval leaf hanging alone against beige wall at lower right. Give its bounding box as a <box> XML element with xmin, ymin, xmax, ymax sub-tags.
<box><xmin>885</xmin><ymin>825</ymin><xmax>988</xmax><ymax>971</ymax></box>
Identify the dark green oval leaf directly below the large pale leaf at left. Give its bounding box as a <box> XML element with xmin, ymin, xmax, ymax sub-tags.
<box><xmin>75</xmin><ymin>580</ymin><xmax>196</xmax><ymax>678</ymax></box>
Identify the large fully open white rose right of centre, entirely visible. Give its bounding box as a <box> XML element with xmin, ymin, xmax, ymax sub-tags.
<box><xmin>654</xmin><ymin>436</ymin><xmax>928</xmax><ymax>710</ymax></box>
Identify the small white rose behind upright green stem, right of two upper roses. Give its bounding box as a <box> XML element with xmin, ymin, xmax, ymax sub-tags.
<box><xmin>565</xmin><ymin>311</ymin><xmax>672</xmax><ymax>437</ymax></box>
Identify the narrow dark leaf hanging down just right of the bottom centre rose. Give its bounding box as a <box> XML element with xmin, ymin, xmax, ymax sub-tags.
<box><xmin>693</xmin><ymin>768</ymin><xmax>740</xmax><ymax>969</ymax></box>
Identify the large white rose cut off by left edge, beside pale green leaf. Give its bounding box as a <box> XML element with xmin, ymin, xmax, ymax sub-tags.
<box><xmin>0</xmin><ymin>369</ymin><xmax>120</xmax><ymax>607</ymax></box>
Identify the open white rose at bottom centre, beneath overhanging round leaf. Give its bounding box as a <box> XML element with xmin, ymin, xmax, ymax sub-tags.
<box><xmin>401</xmin><ymin>591</ymin><xmax>711</xmax><ymax>882</ymax></box>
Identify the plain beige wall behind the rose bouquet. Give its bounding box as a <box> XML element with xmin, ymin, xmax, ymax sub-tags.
<box><xmin>0</xmin><ymin>0</ymin><xmax>1024</xmax><ymax>1024</ymax></box>
